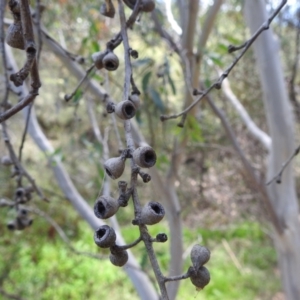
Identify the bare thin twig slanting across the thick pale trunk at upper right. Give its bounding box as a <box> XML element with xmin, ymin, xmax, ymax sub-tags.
<box><xmin>160</xmin><ymin>0</ymin><xmax>287</xmax><ymax>121</ymax></box>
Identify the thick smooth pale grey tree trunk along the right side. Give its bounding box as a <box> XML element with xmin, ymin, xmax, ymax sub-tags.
<box><xmin>245</xmin><ymin>0</ymin><xmax>300</xmax><ymax>300</ymax></box>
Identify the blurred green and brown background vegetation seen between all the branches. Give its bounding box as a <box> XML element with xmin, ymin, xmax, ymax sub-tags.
<box><xmin>0</xmin><ymin>0</ymin><xmax>300</xmax><ymax>300</ymax></box>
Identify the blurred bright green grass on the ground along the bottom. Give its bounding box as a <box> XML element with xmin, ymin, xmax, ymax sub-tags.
<box><xmin>0</xmin><ymin>204</ymin><xmax>280</xmax><ymax>300</ymax></box>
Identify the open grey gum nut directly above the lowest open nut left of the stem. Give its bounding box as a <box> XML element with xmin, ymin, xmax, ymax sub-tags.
<box><xmin>94</xmin><ymin>196</ymin><xmax>119</xmax><ymax>219</ymax></box>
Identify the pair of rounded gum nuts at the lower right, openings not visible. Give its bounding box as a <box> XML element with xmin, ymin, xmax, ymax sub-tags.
<box><xmin>189</xmin><ymin>245</ymin><xmax>210</xmax><ymax>289</ymax></box>
